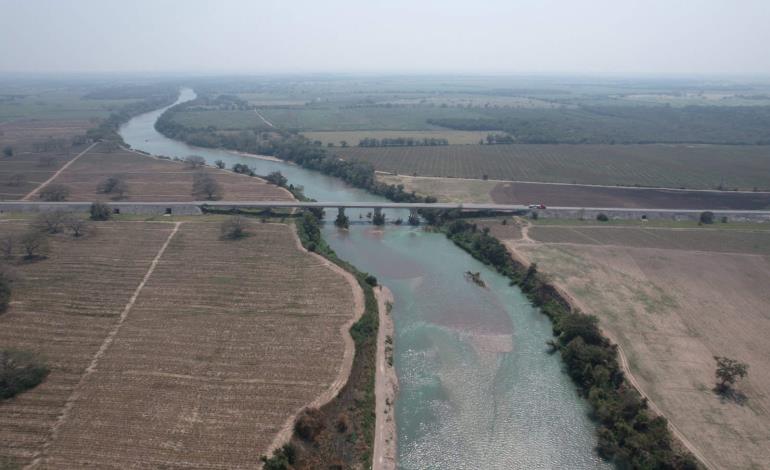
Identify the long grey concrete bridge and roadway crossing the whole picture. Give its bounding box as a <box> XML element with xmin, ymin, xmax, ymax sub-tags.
<box><xmin>0</xmin><ymin>201</ymin><xmax>770</xmax><ymax>222</ymax></box>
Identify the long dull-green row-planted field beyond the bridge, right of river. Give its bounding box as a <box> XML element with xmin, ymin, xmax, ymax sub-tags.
<box><xmin>335</xmin><ymin>144</ymin><xmax>770</xmax><ymax>190</ymax></box>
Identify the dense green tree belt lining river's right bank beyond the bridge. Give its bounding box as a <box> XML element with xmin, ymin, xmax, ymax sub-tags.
<box><xmin>155</xmin><ymin>102</ymin><xmax>436</xmax><ymax>202</ymax></box>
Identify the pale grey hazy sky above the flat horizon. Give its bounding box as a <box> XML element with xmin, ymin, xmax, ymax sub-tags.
<box><xmin>0</xmin><ymin>0</ymin><xmax>770</xmax><ymax>76</ymax></box>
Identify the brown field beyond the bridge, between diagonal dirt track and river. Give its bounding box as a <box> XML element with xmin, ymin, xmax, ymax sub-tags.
<box><xmin>39</xmin><ymin>145</ymin><xmax>292</xmax><ymax>202</ymax></box>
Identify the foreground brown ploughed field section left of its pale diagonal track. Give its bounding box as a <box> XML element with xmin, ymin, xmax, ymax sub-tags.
<box><xmin>0</xmin><ymin>221</ymin><xmax>173</xmax><ymax>464</ymax></box>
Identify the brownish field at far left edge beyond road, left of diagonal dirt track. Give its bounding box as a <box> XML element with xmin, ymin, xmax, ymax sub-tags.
<box><xmin>0</xmin><ymin>120</ymin><xmax>93</xmax><ymax>200</ymax></box>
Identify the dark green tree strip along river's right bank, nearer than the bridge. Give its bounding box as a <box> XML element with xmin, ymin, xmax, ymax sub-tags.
<box><xmin>433</xmin><ymin>218</ymin><xmax>698</xmax><ymax>470</ymax></box>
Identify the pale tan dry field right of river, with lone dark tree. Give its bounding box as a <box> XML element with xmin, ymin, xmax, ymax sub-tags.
<box><xmin>488</xmin><ymin>221</ymin><xmax>770</xmax><ymax>469</ymax></box>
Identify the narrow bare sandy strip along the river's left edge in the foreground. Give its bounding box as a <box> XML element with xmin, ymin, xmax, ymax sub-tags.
<box><xmin>372</xmin><ymin>286</ymin><xmax>398</xmax><ymax>470</ymax></box>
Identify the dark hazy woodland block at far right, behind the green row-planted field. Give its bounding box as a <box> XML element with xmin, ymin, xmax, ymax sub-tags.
<box><xmin>428</xmin><ymin>106</ymin><xmax>770</xmax><ymax>145</ymax></box>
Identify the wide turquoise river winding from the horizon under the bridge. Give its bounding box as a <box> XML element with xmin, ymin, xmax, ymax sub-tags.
<box><xmin>120</xmin><ymin>89</ymin><xmax>611</xmax><ymax>470</ymax></box>
